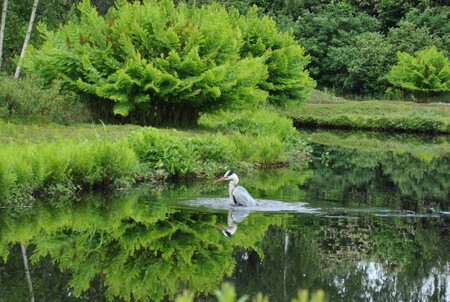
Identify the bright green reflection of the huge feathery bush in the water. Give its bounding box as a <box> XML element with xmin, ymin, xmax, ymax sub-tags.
<box><xmin>0</xmin><ymin>190</ymin><xmax>281</xmax><ymax>300</ymax></box>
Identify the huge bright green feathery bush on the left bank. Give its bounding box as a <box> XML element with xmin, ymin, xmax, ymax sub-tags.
<box><xmin>22</xmin><ymin>0</ymin><xmax>314</xmax><ymax>125</ymax></box>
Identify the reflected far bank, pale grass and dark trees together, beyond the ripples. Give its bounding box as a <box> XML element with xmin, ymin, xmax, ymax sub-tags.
<box><xmin>300</xmin><ymin>132</ymin><xmax>450</xmax><ymax>210</ymax></box>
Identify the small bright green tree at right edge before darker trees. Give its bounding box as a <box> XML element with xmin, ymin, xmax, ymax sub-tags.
<box><xmin>387</xmin><ymin>46</ymin><xmax>450</xmax><ymax>96</ymax></box>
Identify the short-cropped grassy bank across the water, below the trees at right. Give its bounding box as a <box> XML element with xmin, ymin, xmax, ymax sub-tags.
<box><xmin>284</xmin><ymin>91</ymin><xmax>450</xmax><ymax>133</ymax></box>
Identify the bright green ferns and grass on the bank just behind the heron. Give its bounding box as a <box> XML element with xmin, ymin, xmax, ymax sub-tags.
<box><xmin>0</xmin><ymin>111</ymin><xmax>310</xmax><ymax>205</ymax></box>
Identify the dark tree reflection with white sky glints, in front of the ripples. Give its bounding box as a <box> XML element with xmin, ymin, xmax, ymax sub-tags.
<box><xmin>233</xmin><ymin>215</ymin><xmax>450</xmax><ymax>301</ymax></box>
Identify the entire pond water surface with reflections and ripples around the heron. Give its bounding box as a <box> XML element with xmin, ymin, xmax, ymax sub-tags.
<box><xmin>0</xmin><ymin>131</ymin><xmax>450</xmax><ymax>301</ymax></box>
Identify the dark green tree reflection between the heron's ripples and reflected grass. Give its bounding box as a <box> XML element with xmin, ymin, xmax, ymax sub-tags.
<box><xmin>302</xmin><ymin>146</ymin><xmax>450</xmax><ymax>211</ymax></box>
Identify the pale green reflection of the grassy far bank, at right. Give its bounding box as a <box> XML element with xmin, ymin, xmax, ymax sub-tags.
<box><xmin>302</xmin><ymin>131</ymin><xmax>450</xmax><ymax>162</ymax></box>
